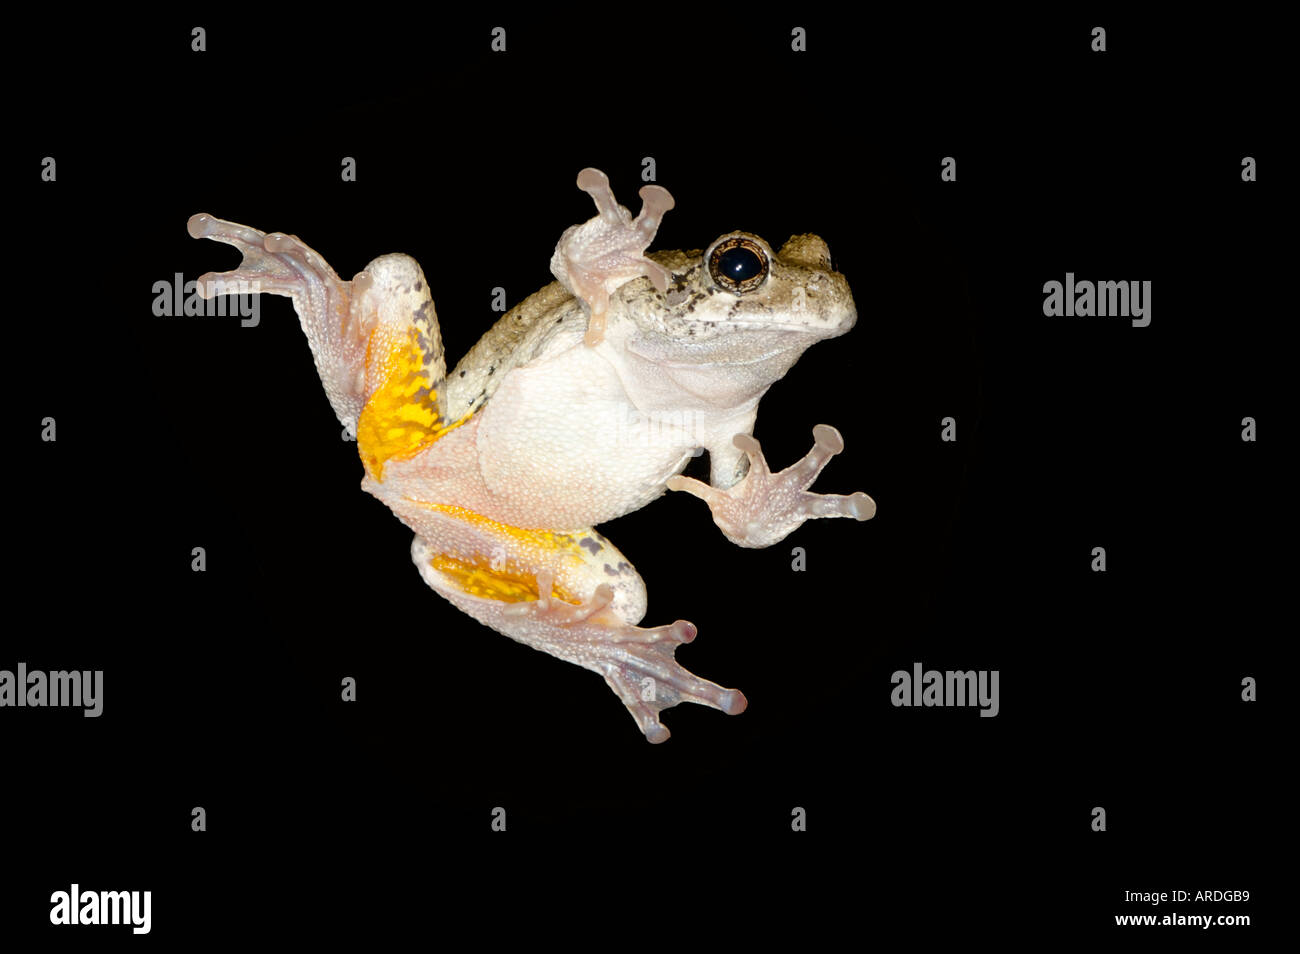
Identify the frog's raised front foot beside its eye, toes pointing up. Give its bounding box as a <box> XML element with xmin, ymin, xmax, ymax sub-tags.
<box><xmin>551</xmin><ymin>169</ymin><xmax>675</xmax><ymax>347</ymax></box>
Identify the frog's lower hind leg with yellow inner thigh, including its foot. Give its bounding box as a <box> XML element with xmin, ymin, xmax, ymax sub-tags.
<box><xmin>411</xmin><ymin>508</ymin><xmax>746</xmax><ymax>742</ymax></box>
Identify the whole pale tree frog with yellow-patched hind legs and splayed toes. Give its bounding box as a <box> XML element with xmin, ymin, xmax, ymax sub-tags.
<box><xmin>187</xmin><ymin>168</ymin><xmax>876</xmax><ymax>743</ymax></box>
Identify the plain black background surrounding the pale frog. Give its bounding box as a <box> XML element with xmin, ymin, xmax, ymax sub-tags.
<box><xmin>0</xmin><ymin>8</ymin><xmax>1294</xmax><ymax>945</ymax></box>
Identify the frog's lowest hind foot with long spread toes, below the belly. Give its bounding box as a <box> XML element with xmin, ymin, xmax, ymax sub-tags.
<box><xmin>502</xmin><ymin>572</ymin><xmax>748</xmax><ymax>742</ymax></box>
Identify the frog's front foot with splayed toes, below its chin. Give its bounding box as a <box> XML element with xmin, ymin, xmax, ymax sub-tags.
<box><xmin>668</xmin><ymin>424</ymin><xmax>876</xmax><ymax>547</ymax></box>
